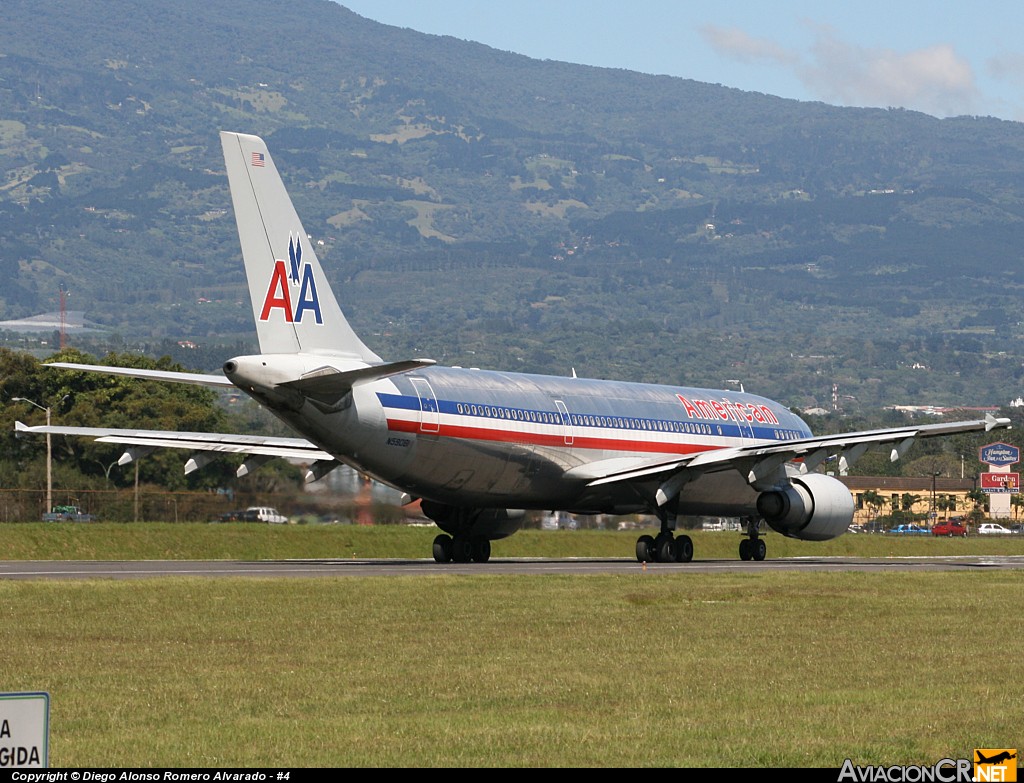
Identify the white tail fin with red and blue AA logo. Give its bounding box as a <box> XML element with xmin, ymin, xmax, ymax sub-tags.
<box><xmin>220</xmin><ymin>132</ymin><xmax>380</xmax><ymax>362</ymax></box>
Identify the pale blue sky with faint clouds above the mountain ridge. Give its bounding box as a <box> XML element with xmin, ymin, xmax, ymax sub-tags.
<box><xmin>338</xmin><ymin>0</ymin><xmax>1024</xmax><ymax>122</ymax></box>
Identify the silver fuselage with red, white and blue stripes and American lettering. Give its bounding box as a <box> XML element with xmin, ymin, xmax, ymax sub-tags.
<box><xmin>235</xmin><ymin>358</ymin><xmax>811</xmax><ymax>516</ymax></box>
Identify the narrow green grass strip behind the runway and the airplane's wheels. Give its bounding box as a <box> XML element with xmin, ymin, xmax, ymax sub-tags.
<box><xmin>6</xmin><ymin>522</ymin><xmax>1024</xmax><ymax>560</ymax></box>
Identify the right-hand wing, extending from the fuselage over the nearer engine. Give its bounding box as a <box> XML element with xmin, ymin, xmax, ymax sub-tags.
<box><xmin>567</xmin><ymin>414</ymin><xmax>1010</xmax><ymax>506</ymax></box>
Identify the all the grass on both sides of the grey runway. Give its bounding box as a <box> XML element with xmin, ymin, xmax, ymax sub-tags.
<box><xmin>0</xmin><ymin>524</ymin><xmax>1024</xmax><ymax>770</ymax></box>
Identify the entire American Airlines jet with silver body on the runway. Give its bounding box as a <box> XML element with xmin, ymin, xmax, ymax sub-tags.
<box><xmin>15</xmin><ymin>132</ymin><xmax>1010</xmax><ymax>563</ymax></box>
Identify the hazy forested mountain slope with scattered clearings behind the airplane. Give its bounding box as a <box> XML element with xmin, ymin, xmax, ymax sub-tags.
<box><xmin>0</xmin><ymin>0</ymin><xmax>1024</xmax><ymax>410</ymax></box>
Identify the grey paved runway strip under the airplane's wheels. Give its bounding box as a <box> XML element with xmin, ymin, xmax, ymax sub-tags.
<box><xmin>0</xmin><ymin>556</ymin><xmax>1024</xmax><ymax>579</ymax></box>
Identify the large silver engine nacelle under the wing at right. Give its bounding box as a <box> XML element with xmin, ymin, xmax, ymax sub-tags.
<box><xmin>758</xmin><ymin>473</ymin><xmax>853</xmax><ymax>541</ymax></box>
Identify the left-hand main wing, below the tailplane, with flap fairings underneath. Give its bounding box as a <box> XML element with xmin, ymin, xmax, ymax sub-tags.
<box><xmin>14</xmin><ymin>422</ymin><xmax>337</xmax><ymax>478</ymax></box>
